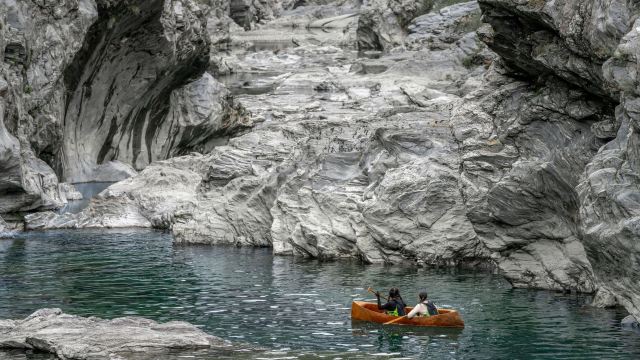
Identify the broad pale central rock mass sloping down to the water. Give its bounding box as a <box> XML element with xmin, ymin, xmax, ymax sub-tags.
<box><xmin>27</xmin><ymin>1</ymin><xmax>609</xmax><ymax>292</ymax></box>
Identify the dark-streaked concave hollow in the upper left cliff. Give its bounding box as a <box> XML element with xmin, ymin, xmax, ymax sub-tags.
<box><xmin>61</xmin><ymin>0</ymin><xmax>209</xmax><ymax>182</ymax></box>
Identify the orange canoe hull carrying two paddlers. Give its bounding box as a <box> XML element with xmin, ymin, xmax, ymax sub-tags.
<box><xmin>351</xmin><ymin>301</ymin><xmax>464</xmax><ymax>328</ymax></box>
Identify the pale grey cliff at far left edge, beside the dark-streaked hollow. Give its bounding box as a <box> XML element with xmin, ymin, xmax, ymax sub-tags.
<box><xmin>0</xmin><ymin>0</ymin><xmax>97</xmax><ymax>213</ymax></box>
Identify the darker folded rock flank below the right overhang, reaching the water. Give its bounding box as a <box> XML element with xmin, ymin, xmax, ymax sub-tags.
<box><xmin>452</xmin><ymin>68</ymin><xmax>610</xmax><ymax>292</ymax></box>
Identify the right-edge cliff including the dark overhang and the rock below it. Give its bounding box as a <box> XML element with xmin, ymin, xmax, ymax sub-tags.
<box><xmin>479</xmin><ymin>0</ymin><xmax>640</xmax><ymax>318</ymax></box>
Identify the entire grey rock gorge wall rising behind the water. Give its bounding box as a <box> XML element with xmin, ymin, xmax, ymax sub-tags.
<box><xmin>0</xmin><ymin>0</ymin><xmax>640</xmax><ymax>318</ymax></box>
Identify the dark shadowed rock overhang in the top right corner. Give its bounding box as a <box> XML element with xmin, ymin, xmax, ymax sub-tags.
<box><xmin>478</xmin><ymin>0</ymin><xmax>637</xmax><ymax>96</ymax></box>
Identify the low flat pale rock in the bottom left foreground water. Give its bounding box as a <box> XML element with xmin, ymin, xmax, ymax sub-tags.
<box><xmin>0</xmin><ymin>309</ymin><xmax>231</xmax><ymax>359</ymax></box>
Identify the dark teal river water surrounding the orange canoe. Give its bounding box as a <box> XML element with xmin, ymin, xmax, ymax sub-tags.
<box><xmin>0</xmin><ymin>230</ymin><xmax>640</xmax><ymax>359</ymax></box>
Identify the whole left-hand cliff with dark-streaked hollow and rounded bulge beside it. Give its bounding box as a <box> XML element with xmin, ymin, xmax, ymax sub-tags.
<box><xmin>0</xmin><ymin>0</ymin><xmax>250</xmax><ymax>216</ymax></box>
